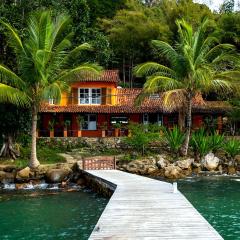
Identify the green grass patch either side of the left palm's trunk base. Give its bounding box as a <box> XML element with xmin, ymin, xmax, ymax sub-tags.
<box><xmin>0</xmin><ymin>147</ymin><xmax>66</xmax><ymax>168</ymax></box>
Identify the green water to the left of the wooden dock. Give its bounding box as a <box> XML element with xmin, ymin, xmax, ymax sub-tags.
<box><xmin>0</xmin><ymin>191</ymin><xmax>108</xmax><ymax>240</ymax></box>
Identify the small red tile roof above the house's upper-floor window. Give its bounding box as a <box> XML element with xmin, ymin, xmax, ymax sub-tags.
<box><xmin>78</xmin><ymin>70</ymin><xmax>120</xmax><ymax>83</ymax></box>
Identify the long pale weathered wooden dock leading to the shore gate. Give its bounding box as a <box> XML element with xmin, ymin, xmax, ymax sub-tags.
<box><xmin>86</xmin><ymin>170</ymin><xmax>223</xmax><ymax>240</ymax></box>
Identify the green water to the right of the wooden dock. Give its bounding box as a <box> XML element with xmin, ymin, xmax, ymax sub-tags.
<box><xmin>178</xmin><ymin>177</ymin><xmax>240</xmax><ymax>240</ymax></box>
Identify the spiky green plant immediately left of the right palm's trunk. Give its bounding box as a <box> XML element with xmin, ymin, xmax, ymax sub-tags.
<box><xmin>164</xmin><ymin>126</ymin><xmax>185</xmax><ymax>157</ymax></box>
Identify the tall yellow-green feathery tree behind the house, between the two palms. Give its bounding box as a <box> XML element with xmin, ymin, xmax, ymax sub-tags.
<box><xmin>102</xmin><ymin>0</ymin><xmax>172</xmax><ymax>87</ymax></box>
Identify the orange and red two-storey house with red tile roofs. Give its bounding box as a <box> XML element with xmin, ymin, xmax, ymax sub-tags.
<box><xmin>38</xmin><ymin>70</ymin><xmax>230</xmax><ymax>137</ymax></box>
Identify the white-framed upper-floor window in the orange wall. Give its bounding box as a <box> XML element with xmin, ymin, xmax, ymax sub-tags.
<box><xmin>78</xmin><ymin>88</ymin><xmax>101</xmax><ymax>104</ymax></box>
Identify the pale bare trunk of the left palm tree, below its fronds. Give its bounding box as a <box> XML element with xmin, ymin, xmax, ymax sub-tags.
<box><xmin>29</xmin><ymin>106</ymin><xmax>40</xmax><ymax>168</ymax></box>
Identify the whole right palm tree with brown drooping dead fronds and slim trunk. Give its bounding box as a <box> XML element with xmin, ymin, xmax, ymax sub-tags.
<box><xmin>135</xmin><ymin>19</ymin><xmax>239</xmax><ymax>155</ymax></box>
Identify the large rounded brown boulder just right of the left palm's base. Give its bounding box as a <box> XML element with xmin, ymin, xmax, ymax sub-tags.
<box><xmin>46</xmin><ymin>169</ymin><xmax>71</xmax><ymax>183</ymax></box>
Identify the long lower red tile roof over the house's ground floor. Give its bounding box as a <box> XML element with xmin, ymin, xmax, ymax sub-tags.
<box><xmin>40</xmin><ymin>89</ymin><xmax>230</xmax><ymax>113</ymax></box>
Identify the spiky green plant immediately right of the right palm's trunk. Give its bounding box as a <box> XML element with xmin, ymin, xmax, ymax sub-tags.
<box><xmin>190</xmin><ymin>128</ymin><xmax>212</xmax><ymax>160</ymax></box>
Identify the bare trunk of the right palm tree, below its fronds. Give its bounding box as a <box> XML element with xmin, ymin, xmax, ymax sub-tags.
<box><xmin>181</xmin><ymin>93</ymin><xmax>192</xmax><ymax>156</ymax></box>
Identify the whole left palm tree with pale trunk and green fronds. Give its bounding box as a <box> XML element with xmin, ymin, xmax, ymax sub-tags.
<box><xmin>0</xmin><ymin>11</ymin><xmax>101</xmax><ymax>168</ymax></box>
